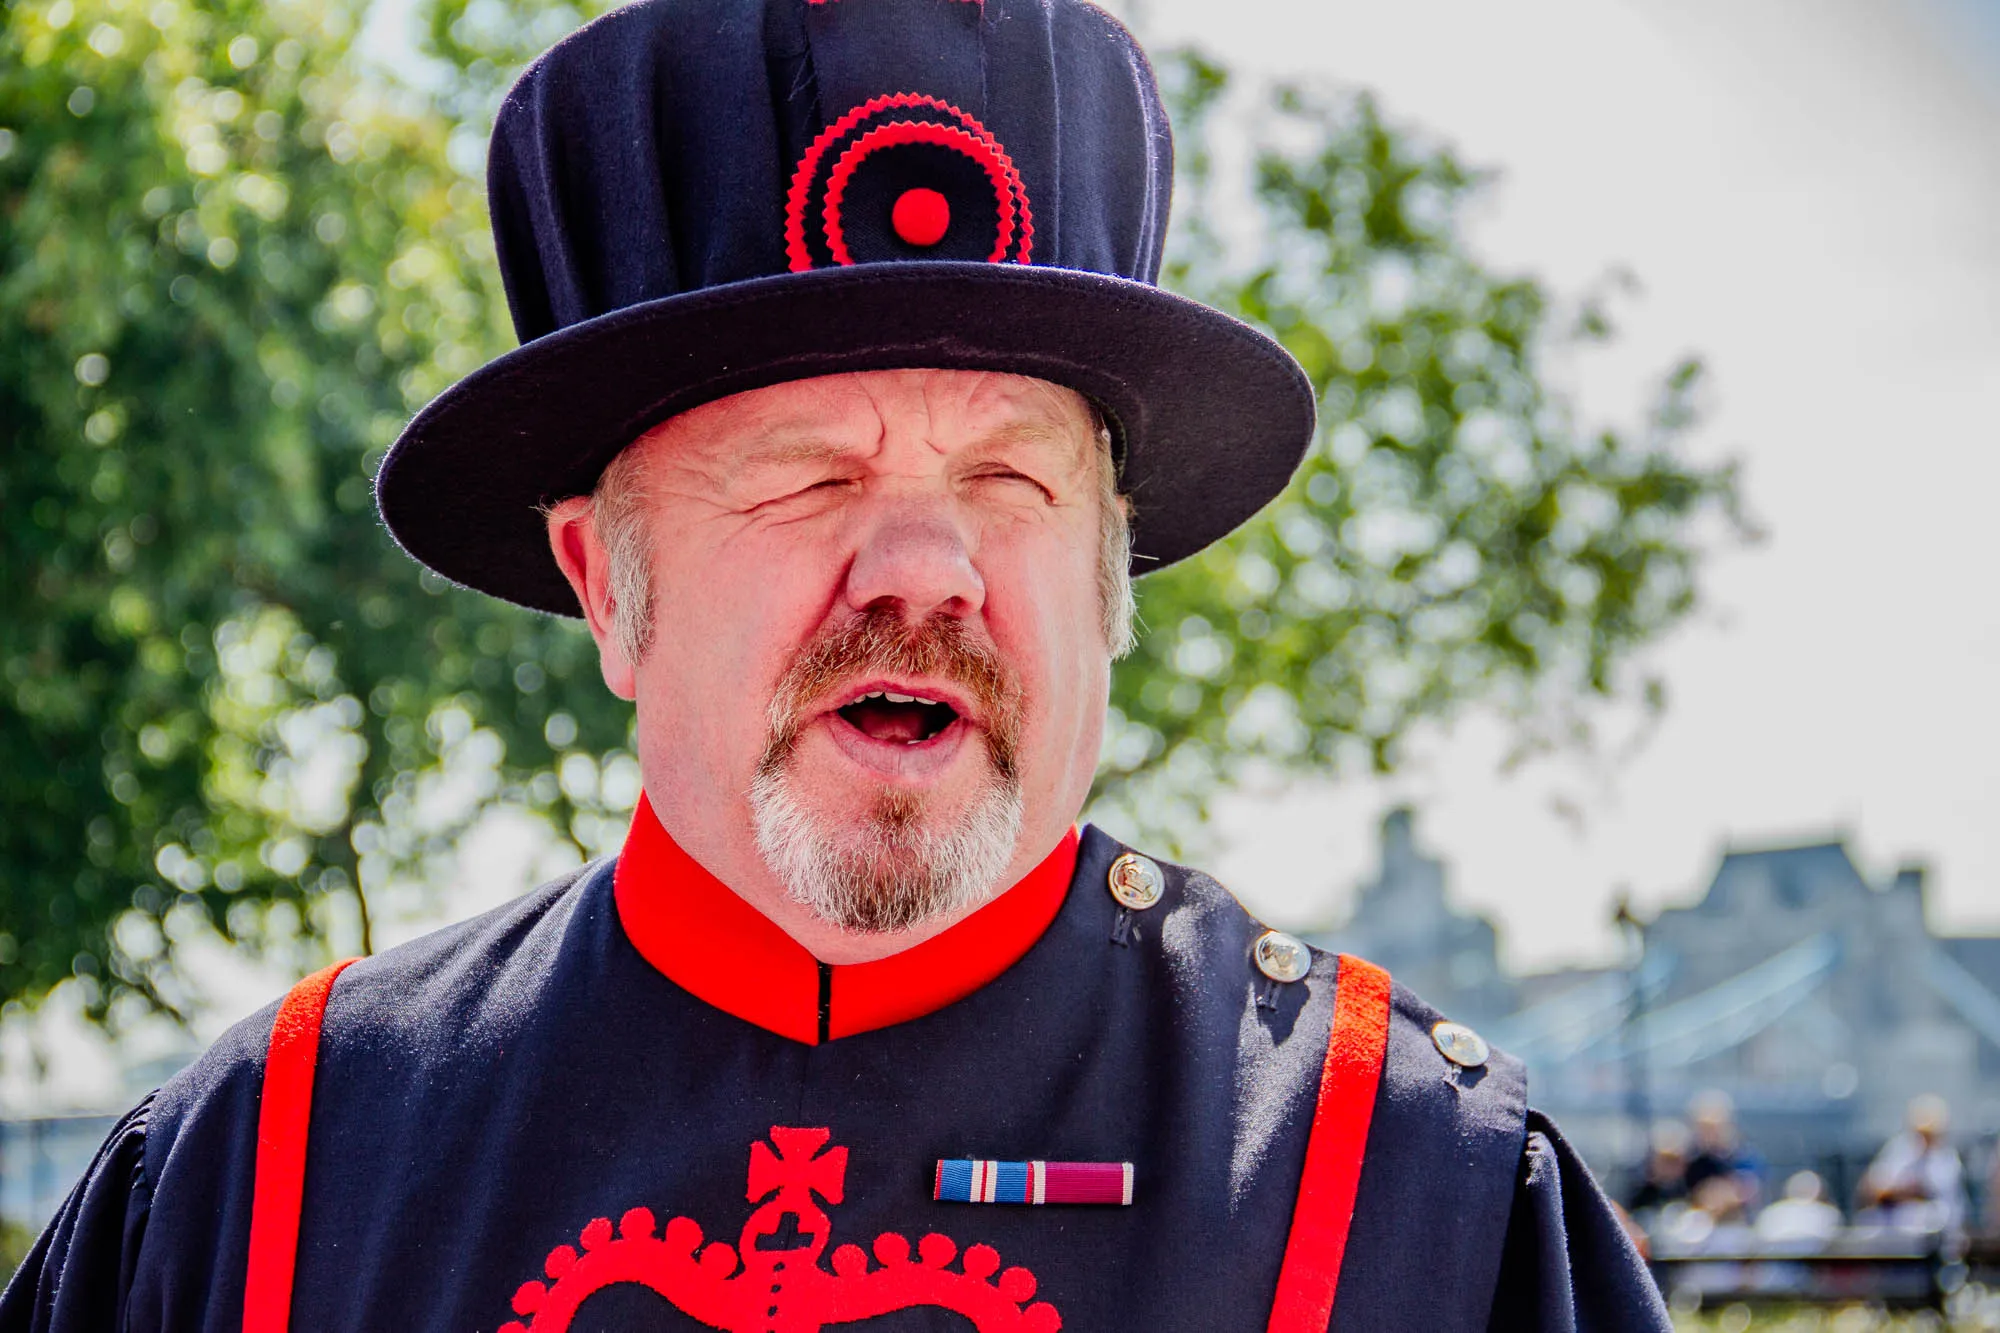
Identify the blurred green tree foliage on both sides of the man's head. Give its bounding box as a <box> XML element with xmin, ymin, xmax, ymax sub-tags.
<box><xmin>0</xmin><ymin>0</ymin><xmax>1732</xmax><ymax>1017</ymax></box>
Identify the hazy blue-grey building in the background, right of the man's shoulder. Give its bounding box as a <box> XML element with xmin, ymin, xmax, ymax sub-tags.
<box><xmin>1314</xmin><ymin>811</ymin><xmax>2000</xmax><ymax>1199</ymax></box>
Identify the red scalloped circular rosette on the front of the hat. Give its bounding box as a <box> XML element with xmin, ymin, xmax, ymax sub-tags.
<box><xmin>784</xmin><ymin>92</ymin><xmax>1034</xmax><ymax>272</ymax></box>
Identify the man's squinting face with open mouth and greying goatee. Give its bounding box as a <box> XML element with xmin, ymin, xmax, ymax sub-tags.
<box><xmin>558</xmin><ymin>370</ymin><xmax>1110</xmax><ymax>931</ymax></box>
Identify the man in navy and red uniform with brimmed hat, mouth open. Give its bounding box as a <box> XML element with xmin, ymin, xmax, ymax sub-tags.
<box><xmin>0</xmin><ymin>0</ymin><xmax>1666</xmax><ymax>1333</ymax></box>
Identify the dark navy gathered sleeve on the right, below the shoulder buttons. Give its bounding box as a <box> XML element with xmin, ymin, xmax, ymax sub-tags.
<box><xmin>1488</xmin><ymin>1111</ymin><xmax>1672</xmax><ymax>1333</ymax></box>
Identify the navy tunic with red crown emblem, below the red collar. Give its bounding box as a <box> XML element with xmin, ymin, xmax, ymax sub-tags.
<box><xmin>0</xmin><ymin>829</ymin><xmax>1668</xmax><ymax>1333</ymax></box>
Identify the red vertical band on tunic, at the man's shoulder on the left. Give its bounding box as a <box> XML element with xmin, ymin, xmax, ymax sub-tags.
<box><xmin>244</xmin><ymin>959</ymin><xmax>356</xmax><ymax>1333</ymax></box>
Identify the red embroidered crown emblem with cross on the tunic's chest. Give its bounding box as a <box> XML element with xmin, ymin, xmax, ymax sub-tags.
<box><xmin>500</xmin><ymin>1125</ymin><xmax>1062</xmax><ymax>1333</ymax></box>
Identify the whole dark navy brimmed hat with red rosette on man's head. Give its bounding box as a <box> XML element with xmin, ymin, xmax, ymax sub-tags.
<box><xmin>376</xmin><ymin>0</ymin><xmax>1312</xmax><ymax>614</ymax></box>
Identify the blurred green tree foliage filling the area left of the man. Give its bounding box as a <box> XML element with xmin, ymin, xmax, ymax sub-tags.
<box><xmin>0</xmin><ymin>0</ymin><xmax>624</xmax><ymax>1009</ymax></box>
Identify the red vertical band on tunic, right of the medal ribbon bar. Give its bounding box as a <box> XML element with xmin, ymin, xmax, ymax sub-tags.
<box><xmin>1270</xmin><ymin>955</ymin><xmax>1390</xmax><ymax>1333</ymax></box>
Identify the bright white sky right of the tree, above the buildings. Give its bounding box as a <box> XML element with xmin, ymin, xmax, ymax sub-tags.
<box><xmin>1126</xmin><ymin>0</ymin><xmax>2000</xmax><ymax>967</ymax></box>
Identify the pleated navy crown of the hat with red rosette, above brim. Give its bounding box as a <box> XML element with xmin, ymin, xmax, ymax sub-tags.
<box><xmin>488</xmin><ymin>0</ymin><xmax>1172</xmax><ymax>342</ymax></box>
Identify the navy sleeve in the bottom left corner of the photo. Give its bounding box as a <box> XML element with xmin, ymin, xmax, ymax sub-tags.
<box><xmin>0</xmin><ymin>1095</ymin><xmax>154</xmax><ymax>1333</ymax></box>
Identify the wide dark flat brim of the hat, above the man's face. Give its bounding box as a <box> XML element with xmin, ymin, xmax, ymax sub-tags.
<box><xmin>376</xmin><ymin>262</ymin><xmax>1314</xmax><ymax>616</ymax></box>
